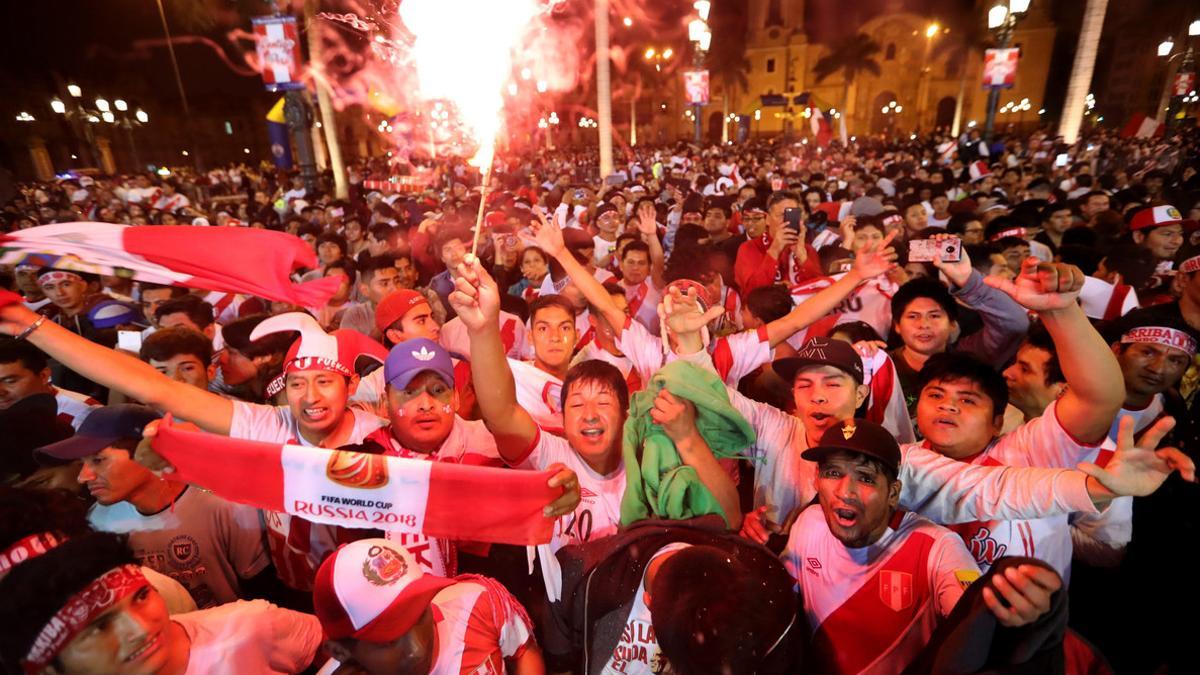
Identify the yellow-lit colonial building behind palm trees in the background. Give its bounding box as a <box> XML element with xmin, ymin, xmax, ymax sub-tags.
<box><xmin>704</xmin><ymin>0</ymin><xmax>1056</xmax><ymax>135</ymax></box>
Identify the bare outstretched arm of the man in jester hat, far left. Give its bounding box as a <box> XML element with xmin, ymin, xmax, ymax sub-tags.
<box><xmin>0</xmin><ymin>299</ymin><xmax>233</xmax><ymax>435</ymax></box>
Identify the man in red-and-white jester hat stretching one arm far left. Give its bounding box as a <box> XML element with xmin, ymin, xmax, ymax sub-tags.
<box><xmin>0</xmin><ymin>305</ymin><xmax>385</xmax><ymax>591</ymax></box>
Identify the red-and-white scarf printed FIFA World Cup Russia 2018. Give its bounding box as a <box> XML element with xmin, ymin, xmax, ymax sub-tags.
<box><xmin>151</xmin><ymin>416</ymin><xmax>562</xmax><ymax>545</ymax></box>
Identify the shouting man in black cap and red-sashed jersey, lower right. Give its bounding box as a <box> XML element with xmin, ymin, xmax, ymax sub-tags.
<box><xmin>782</xmin><ymin>419</ymin><xmax>1067</xmax><ymax>674</ymax></box>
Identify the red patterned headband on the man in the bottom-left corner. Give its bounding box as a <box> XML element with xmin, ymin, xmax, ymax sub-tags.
<box><xmin>20</xmin><ymin>565</ymin><xmax>149</xmax><ymax>674</ymax></box>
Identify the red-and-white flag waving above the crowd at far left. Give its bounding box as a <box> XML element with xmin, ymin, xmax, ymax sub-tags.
<box><xmin>0</xmin><ymin>222</ymin><xmax>342</xmax><ymax>307</ymax></box>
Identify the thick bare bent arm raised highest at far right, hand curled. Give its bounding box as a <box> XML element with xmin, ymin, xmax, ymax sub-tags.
<box><xmin>986</xmin><ymin>258</ymin><xmax>1124</xmax><ymax>442</ymax></box>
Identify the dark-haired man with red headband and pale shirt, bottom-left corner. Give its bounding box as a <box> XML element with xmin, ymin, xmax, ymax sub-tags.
<box><xmin>0</xmin><ymin>532</ymin><xmax>322</xmax><ymax>675</ymax></box>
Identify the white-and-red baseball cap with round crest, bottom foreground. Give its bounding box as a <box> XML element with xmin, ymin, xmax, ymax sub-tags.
<box><xmin>312</xmin><ymin>539</ymin><xmax>454</xmax><ymax>643</ymax></box>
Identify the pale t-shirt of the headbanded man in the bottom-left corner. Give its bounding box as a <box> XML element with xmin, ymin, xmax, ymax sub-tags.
<box><xmin>172</xmin><ymin>601</ymin><xmax>324</xmax><ymax>675</ymax></box>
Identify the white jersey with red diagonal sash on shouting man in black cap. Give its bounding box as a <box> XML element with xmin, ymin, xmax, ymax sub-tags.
<box><xmin>782</xmin><ymin>506</ymin><xmax>979</xmax><ymax>674</ymax></box>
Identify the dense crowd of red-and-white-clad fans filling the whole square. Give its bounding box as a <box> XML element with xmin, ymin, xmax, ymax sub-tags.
<box><xmin>0</xmin><ymin>121</ymin><xmax>1200</xmax><ymax>675</ymax></box>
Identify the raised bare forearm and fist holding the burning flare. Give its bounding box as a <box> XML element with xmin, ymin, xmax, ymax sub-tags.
<box><xmin>449</xmin><ymin>254</ymin><xmax>538</xmax><ymax>464</ymax></box>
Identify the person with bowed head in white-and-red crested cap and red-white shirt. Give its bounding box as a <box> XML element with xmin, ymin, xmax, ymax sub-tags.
<box><xmin>313</xmin><ymin>539</ymin><xmax>545</xmax><ymax>675</ymax></box>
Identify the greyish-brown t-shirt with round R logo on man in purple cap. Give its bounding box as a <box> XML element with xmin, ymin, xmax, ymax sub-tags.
<box><xmin>88</xmin><ymin>486</ymin><xmax>270</xmax><ymax>608</ymax></box>
